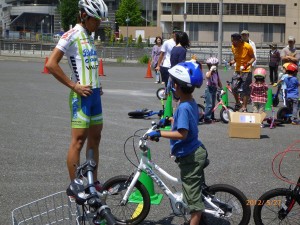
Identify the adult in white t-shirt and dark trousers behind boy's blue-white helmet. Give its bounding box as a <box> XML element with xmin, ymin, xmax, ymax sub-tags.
<box><xmin>155</xmin><ymin>29</ymin><xmax>178</xmax><ymax>87</ymax></box>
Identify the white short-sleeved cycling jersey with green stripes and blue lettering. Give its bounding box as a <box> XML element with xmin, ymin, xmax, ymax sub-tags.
<box><xmin>56</xmin><ymin>24</ymin><xmax>100</xmax><ymax>88</ymax></box>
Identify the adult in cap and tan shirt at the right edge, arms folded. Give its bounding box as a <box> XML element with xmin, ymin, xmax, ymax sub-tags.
<box><xmin>280</xmin><ymin>36</ymin><xmax>300</xmax><ymax>65</ymax></box>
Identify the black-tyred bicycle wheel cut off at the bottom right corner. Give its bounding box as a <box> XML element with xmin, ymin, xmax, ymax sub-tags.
<box><xmin>253</xmin><ymin>188</ymin><xmax>300</xmax><ymax>225</ymax></box>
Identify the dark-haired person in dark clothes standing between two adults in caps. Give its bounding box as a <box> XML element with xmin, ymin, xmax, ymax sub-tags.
<box><xmin>269</xmin><ymin>43</ymin><xmax>281</xmax><ymax>85</ymax></box>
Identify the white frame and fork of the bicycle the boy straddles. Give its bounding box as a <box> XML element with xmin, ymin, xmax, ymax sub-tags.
<box><xmin>122</xmin><ymin>149</ymin><xmax>224</xmax><ymax>217</ymax></box>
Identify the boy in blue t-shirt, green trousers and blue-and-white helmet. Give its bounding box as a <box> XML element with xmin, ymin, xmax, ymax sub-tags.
<box><xmin>148</xmin><ymin>61</ymin><xmax>207</xmax><ymax>225</ymax></box>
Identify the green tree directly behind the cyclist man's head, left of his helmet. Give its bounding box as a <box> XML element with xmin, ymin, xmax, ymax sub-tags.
<box><xmin>59</xmin><ymin>0</ymin><xmax>79</xmax><ymax>31</ymax></box>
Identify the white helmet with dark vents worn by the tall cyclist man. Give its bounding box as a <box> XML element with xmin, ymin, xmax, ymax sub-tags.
<box><xmin>78</xmin><ymin>0</ymin><xmax>108</xmax><ymax>19</ymax></box>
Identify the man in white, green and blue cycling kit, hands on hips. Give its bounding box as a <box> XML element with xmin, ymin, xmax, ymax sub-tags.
<box><xmin>46</xmin><ymin>0</ymin><xmax>107</xmax><ymax>189</ymax></box>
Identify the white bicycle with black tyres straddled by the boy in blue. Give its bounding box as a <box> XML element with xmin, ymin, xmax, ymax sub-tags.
<box><xmin>103</xmin><ymin>122</ymin><xmax>251</xmax><ymax>225</ymax></box>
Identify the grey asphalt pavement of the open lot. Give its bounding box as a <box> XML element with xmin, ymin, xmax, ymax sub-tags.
<box><xmin>0</xmin><ymin>57</ymin><xmax>300</xmax><ymax>225</ymax></box>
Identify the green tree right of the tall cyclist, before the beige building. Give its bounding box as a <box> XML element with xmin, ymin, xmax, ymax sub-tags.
<box><xmin>116</xmin><ymin>0</ymin><xmax>143</xmax><ymax>26</ymax></box>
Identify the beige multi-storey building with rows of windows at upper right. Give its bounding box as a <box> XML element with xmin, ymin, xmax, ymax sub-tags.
<box><xmin>157</xmin><ymin>0</ymin><xmax>300</xmax><ymax>45</ymax></box>
